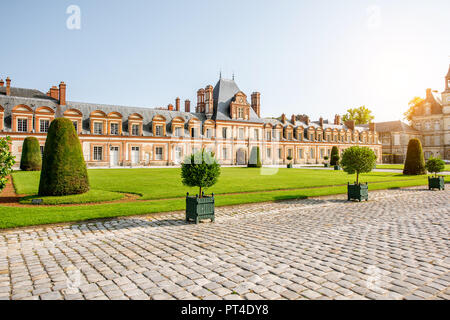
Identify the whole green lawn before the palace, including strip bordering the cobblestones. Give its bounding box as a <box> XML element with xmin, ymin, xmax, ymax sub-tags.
<box><xmin>0</xmin><ymin>168</ymin><xmax>450</xmax><ymax>228</ymax></box>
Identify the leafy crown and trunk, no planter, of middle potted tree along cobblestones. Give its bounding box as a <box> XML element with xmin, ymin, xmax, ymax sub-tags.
<box><xmin>341</xmin><ymin>146</ymin><xmax>377</xmax><ymax>184</ymax></box>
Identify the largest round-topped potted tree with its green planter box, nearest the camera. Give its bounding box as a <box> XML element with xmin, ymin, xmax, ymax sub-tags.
<box><xmin>181</xmin><ymin>150</ymin><xmax>220</xmax><ymax>224</ymax></box>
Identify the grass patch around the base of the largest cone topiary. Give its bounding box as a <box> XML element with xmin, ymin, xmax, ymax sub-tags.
<box><xmin>20</xmin><ymin>190</ymin><xmax>124</xmax><ymax>205</ymax></box>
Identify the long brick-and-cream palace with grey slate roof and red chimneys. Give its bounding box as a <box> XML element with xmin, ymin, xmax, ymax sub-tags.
<box><xmin>0</xmin><ymin>78</ymin><xmax>382</xmax><ymax>167</ymax></box>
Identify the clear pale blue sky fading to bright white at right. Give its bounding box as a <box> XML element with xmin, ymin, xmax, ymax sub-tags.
<box><xmin>0</xmin><ymin>0</ymin><xmax>450</xmax><ymax>121</ymax></box>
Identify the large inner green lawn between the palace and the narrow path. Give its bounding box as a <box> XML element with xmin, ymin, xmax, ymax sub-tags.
<box><xmin>13</xmin><ymin>168</ymin><xmax>434</xmax><ymax>200</ymax></box>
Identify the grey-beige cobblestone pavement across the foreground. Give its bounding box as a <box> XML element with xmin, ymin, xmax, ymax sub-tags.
<box><xmin>0</xmin><ymin>188</ymin><xmax>450</xmax><ymax>300</ymax></box>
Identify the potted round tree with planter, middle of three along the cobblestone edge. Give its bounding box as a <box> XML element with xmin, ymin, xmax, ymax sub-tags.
<box><xmin>341</xmin><ymin>146</ymin><xmax>377</xmax><ymax>201</ymax></box>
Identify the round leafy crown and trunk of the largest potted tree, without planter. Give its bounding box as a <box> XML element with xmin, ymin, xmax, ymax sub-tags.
<box><xmin>181</xmin><ymin>149</ymin><xmax>220</xmax><ymax>198</ymax></box>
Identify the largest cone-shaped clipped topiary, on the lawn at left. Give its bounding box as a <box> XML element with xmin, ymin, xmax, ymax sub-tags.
<box><xmin>39</xmin><ymin>118</ymin><xmax>89</xmax><ymax>196</ymax></box>
